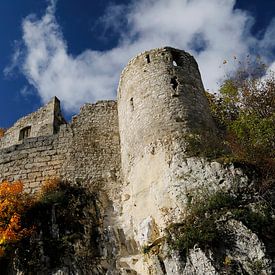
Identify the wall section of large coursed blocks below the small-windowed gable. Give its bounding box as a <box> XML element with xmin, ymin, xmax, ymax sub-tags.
<box><xmin>0</xmin><ymin>125</ymin><xmax>71</xmax><ymax>193</ymax></box>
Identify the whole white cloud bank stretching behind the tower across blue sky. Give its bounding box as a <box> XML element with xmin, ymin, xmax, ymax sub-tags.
<box><xmin>7</xmin><ymin>0</ymin><xmax>275</xmax><ymax>112</ymax></box>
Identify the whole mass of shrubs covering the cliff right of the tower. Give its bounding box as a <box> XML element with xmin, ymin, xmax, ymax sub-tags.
<box><xmin>167</xmin><ymin>62</ymin><xmax>275</xmax><ymax>274</ymax></box>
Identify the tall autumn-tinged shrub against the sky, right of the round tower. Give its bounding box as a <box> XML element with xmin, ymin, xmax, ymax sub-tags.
<box><xmin>207</xmin><ymin>63</ymin><xmax>275</xmax><ymax>182</ymax></box>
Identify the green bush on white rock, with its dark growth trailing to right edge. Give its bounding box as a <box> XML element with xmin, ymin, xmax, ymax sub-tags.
<box><xmin>167</xmin><ymin>191</ymin><xmax>275</xmax><ymax>257</ymax></box>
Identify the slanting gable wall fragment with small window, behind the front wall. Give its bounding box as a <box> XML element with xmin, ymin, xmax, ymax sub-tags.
<box><xmin>0</xmin><ymin>97</ymin><xmax>65</xmax><ymax>148</ymax></box>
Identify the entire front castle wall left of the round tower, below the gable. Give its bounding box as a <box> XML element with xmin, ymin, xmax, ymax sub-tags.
<box><xmin>0</xmin><ymin>101</ymin><xmax>120</xmax><ymax>193</ymax></box>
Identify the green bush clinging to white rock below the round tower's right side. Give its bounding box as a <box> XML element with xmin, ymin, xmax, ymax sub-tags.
<box><xmin>167</xmin><ymin>191</ymin><xmax>237</xmax><ymax>255</ymax></box>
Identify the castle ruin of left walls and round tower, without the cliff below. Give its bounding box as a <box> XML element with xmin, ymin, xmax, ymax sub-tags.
<box><xmin>0</xmin><ymin>47</ymin><xmax>215</xmax><ymax>195</ymax></box>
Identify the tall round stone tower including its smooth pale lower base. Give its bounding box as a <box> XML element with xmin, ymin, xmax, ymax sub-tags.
<box><xmin>118</xmin><ymin>47</ymin><xmax>219</xmax><ymax>235</ymax></box>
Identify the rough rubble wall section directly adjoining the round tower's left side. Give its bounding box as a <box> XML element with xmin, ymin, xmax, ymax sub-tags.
<box><xmin>63</xmin><ymin>101</ymin><xmax>120</xmax><ymax>191</ymax></box>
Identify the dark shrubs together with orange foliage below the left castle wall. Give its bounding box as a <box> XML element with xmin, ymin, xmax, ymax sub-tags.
<box><xmin>0</xmin><ymin>180</ymin><xmax>102</xmax><ymax>274</ymax></box>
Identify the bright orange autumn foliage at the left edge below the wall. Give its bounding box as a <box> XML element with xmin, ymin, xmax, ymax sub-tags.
<box><xmin>0</xmin><ymin>179</ymin><xmax>63</xmax><ymax>259</ymax></box>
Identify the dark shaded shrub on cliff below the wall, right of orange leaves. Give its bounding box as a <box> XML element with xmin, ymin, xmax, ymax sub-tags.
<box><xmin>13</xmin><ymin>180</ymin><xmax>99</xmax><ymax>274</ymax></box>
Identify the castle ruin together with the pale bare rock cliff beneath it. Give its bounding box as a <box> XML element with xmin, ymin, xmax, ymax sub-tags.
<box><xmin>0</xmin><ymin>47</ymin><xmax>272</xmax><ymax>275</ymax></box>
